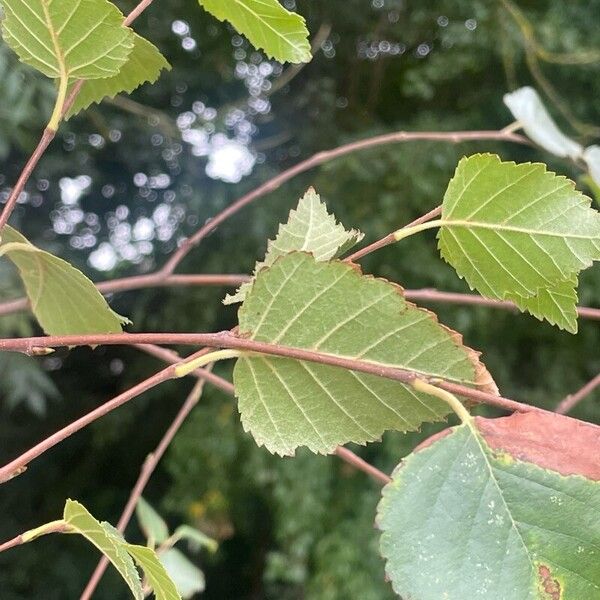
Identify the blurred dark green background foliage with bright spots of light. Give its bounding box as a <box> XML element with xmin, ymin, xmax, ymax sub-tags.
<box><xmin>0</xmin><ymin>0</ymin><xmax>600</xmax><ymax>600</ymax></box>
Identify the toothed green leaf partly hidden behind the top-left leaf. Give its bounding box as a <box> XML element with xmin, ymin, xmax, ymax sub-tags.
<box><xmin>66</xmin><ymin>34</ymin><xmax>171</xmax><ymax>118</ymax></box>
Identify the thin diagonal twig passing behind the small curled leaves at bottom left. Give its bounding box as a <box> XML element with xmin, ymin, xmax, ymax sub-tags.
<box><xmin>80</xmin><ymin>379</ymin><xmax>211</xmax><ymax>600</ymax></box>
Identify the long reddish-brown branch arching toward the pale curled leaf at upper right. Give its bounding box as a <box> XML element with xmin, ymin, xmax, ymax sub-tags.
<box><xmin>161</xmin><ymin>131</ymin><xmax>529</xmax><ymax>276</ymax></box>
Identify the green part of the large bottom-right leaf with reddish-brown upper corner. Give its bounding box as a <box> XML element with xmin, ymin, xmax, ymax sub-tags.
<box><xmin>377</xmin><ymin>422</ymin><xmax>600</xmax><ymax>600</ymax></box>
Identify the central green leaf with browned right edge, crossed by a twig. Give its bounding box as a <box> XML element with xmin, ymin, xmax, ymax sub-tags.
<box><xmin>234</xmin><ymin>252</ymin><xmax>495</xmax><ymax>455</ymax></box>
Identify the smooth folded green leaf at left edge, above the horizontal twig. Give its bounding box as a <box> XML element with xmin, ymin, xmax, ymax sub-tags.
<box><xmin>0</xmin><ymin>225</ymin><xmax>128</xmax><ymax>335</ymax></box>
